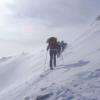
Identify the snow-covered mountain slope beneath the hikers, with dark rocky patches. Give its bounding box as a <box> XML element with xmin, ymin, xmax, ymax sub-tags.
<box><xmin>0</xmin><ymin>21</ymin><xmax>100</xmax><ymax>100</ymax></box>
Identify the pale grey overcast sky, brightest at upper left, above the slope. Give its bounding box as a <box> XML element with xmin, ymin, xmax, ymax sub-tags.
<box><xmin>0</xmin><ymin>0</ymin><xmax>100</xmax><ymax>56</ymax></box>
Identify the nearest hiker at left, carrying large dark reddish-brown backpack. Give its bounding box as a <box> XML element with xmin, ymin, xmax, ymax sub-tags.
<box><xmin>47</xmin><ymin>37</ymin><xmax>57</xmax><ymax>70</ymax></box>
